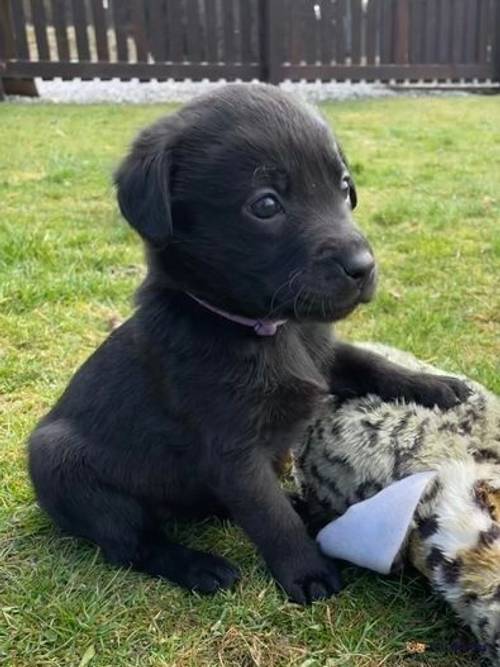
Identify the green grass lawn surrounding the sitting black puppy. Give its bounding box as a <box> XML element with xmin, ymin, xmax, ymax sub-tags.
<box><xmin>0</xmin><ymin>97</ymin><xmax>500</xmax><ymax>667</ymax></box>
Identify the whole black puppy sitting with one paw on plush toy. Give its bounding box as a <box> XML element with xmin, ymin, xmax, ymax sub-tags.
<box><xmin>29</xmin><ymin>85</ymin><xmax>465</xmax><ymax>603</ymax></box>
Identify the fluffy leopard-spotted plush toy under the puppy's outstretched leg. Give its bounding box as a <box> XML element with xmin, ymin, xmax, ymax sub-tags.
<box><xmin>294</xmin><ymin>345</ymin><xmax>500</xmax><ymax>665</ymax></box>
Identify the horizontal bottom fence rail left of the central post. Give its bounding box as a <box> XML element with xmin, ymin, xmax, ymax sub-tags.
<box><xmin>3</xmin><ymin>59</ymin><xmax>262</xmax><ymax>81</ymax></box>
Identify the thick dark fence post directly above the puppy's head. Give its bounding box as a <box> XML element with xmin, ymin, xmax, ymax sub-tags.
<box><xmin>259</xmin><ymin>0</ymin><xmax>283</xmax><ymax>84</ymax></box>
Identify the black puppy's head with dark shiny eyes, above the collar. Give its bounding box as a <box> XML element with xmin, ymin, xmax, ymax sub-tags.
<box><xmin>116</xmin><ymin>85</ymin><xmax>375</xmax><ymax>321</ymax></box>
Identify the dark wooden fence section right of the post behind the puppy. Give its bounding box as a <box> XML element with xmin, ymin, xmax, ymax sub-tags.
<box><xmin>279</xmin><ymin>0</ymin><xmax>500</xmax><ymax>82</ymax></box>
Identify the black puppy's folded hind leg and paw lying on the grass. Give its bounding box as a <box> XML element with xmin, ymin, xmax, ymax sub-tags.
<box><xmin>30</xmin><ymin>422</ymin><xmax>238</xmax><ymax>593</ymax></box>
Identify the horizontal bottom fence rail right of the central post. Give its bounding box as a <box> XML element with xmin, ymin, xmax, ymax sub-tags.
<box><xmin>282</xmin><ymin>64</ymin><xmax>492</xmax><ymax>81</ymax></box>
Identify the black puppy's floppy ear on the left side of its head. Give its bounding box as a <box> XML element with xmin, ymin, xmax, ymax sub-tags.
<box><xmin>115</xmin><ymin>128</ymin><xmax>172</xmax><ymax>248</ymax></box>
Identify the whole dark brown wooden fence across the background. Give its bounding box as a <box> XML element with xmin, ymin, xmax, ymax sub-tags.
<box><xmin>0</xmin><ymin>0</ymin><xmax>500</xmax><ymax>98</ymax></box>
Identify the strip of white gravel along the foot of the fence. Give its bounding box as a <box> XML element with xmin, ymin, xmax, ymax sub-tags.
<box><xmin>7</xmin><ymin>79</ymin><xmax>480</xmax><ymax>104</ymax></box>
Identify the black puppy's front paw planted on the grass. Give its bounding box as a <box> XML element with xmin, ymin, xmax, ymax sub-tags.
<box><xmin>274</xmin><ymin>550</ymin><xmax>341</xmax><ymax>605</ymax></box>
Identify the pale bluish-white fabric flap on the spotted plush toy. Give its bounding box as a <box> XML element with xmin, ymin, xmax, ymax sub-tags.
<box><xmin>316</xmin><ymin>471</ymin><xmax>437</xmax><ymax>574</ymax></box>
